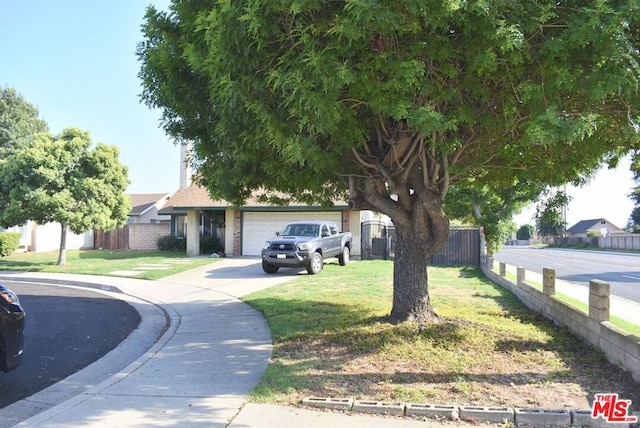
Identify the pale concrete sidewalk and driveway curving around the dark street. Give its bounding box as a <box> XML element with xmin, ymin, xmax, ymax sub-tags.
<box><xmin>0</xmin><ymin>258</ymin><xmax>640</xmax><ymax>428</ymax></box>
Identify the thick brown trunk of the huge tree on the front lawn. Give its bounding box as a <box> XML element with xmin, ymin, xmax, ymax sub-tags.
<box><xmin>390</xmin><ymin>222</ymin><xmax>438</xmax><ymax>324</ymax></box>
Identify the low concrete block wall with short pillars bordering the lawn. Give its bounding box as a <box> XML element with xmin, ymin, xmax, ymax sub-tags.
<box><xmin>482</xmin><ymin>263</ymin><xmax>640</xmax><ymax>382</ymax></box>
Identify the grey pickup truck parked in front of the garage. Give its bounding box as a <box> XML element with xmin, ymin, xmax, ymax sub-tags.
<box><xmin>262</xmin><ymin>221</ymin><xmax>352</xmax><ymax>274</ymax></box>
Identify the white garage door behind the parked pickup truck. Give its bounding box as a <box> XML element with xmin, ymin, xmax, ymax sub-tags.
<box><xmin>242</xmin><ymin>211</ymin><xmax>342</xmax><ymax>256</ymax></box>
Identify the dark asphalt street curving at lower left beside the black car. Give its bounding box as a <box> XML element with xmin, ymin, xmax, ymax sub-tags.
<box><xmin>0</xmin><ymin>282</ymin><xmax>140</xmax><ymax>408</ymax></box>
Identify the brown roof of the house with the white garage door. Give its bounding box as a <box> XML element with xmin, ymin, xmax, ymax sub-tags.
<box><xmin>158</xmin><ymin>184</ymin><xmax>348</xmax><ymax>214</ymax></box>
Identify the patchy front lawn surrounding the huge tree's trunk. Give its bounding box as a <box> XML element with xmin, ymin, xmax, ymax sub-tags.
<box><xmin>245</xmin><ymin>261</ymin><xmax>640</xmax><ymax>409</ymax></box>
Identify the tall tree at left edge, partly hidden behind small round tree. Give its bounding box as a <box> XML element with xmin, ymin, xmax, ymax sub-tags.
<box><xmin>0</xmin><ymin>87</ymin><xmax>48</xmax><ymax>158</ymax></box>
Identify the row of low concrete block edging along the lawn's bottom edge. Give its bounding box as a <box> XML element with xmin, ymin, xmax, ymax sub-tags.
<box><xmin>302</xmin><ymin>397</ymin><xmax>629</xmax><ymax>428</ymax></box>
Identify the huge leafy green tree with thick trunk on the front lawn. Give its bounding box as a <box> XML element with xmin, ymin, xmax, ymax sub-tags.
<box><xmin>138</xmin><ymin>0</ymin><xmax>640</xmax><ymax>322</ymax></box>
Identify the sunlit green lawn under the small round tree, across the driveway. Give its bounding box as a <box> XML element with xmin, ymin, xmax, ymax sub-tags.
<box><xmin>0</xmin><ymin>250</ymin><xmax>219</xmax><ymax>279</ymax></box>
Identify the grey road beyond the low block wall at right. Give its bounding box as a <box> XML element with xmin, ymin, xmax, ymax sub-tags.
<box><xmin>494</xmin><ymin>246</ymin><xmax>640</xmax><ymax>302</ymax></box>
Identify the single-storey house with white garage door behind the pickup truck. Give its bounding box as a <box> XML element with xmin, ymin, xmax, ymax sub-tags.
<box><xmin>159</xmin><ymin>185</ymin><xmax>360</xmax><ymax>256</ymax></box>
